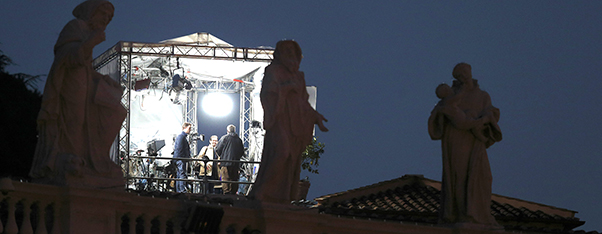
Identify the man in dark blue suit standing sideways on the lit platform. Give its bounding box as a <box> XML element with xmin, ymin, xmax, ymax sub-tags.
<box><xmin>173</xmin><ymin>122</ymin><xmax>192</xmax><ymax>193</ymax></box>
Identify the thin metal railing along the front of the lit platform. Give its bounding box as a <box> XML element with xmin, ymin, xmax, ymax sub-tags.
<box><xmin>126</xmin><ymin>155</ymin><xmax>261</xmax><ymax>195</ymax></box>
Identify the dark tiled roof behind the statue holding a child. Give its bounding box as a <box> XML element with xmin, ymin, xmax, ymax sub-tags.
<box><xmin>315</xmin><ymin>175</ymin><xmax>585</xmax><ymax>233</ymax></box>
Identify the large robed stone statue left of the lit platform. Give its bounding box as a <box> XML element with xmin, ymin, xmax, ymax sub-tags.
<box><xmin>30</xmin><ymin>0</ymin><xmax>126</xmax><ymax>188</ymax></box>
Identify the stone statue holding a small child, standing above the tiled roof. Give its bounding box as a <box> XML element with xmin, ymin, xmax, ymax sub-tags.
<box><xmin>428</xmin><ymin>63</ymin><xmax>502</xmax><ymax>229</ymax></box>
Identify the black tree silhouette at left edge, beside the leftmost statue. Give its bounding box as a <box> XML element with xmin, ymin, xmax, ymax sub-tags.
<box><xmin>0</xmin><ymin>50</ymin><xmax>42</xmax><ymax>178</ymax></box>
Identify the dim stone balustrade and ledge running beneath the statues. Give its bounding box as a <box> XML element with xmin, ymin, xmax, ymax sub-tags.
<box><xmin>0</xmin><ymin>178</ymin><xmax>500</xmax><ymax>234</ymax></box>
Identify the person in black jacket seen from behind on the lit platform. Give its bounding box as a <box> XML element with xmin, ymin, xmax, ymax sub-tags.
<box><xmin>215</xmin><ymin>124</ymin><xmax>245</xmax><ymax>194</ymax></box>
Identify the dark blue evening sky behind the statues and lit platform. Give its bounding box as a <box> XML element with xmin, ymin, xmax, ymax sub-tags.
<box><xmin>0</xmin><ymin>0</ymin><xmax>602</xmax><ymax>231</ymax></box>
